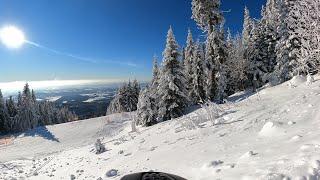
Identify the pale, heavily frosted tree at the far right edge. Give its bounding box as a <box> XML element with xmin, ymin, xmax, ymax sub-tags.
<box><xmin>289</xmin><ymin>0</ymin><xmax>320</xmax><ymax>75</ymax></box>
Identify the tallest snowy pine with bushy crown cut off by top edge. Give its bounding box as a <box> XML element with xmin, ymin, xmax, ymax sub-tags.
<box><xmin>192</xmin><ymin>0</ymin><xmax>226</xmax><ymax>101</ymax></box>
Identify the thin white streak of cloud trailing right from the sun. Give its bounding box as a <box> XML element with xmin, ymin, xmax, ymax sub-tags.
<box><xmin>26</xmin><ymin>40</ymin><xmax>138</xmax><ymax>67</ymax></box>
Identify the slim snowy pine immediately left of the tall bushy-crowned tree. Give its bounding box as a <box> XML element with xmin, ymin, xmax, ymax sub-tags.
<box><xmin>189</xmin><ymin>41</ymin><xmax>206</xmax><ymax>104</ymax></box>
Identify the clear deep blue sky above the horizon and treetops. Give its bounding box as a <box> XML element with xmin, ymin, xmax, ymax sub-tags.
<box><xmin>0</xmin><ymin>0</ymin><xmax>266</xmax><ymax>82</ymax></box>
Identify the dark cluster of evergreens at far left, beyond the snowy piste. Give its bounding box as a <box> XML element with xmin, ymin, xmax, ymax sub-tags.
<box><xmin>0</xmin><ymin>84</ymin><xmax>77</xmax><ymax>134</ymax></box>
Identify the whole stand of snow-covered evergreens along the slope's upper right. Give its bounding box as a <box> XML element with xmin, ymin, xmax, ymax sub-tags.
<box><xmin>133</xmin><ymin>0</ymin><xmax>320</xmax><ymax>126</ymax></box>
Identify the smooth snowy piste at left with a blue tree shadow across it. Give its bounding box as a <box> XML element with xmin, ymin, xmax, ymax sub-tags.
<box><xmin>0</xmin><ymin>114</ymin><xmax>130</xmax><ymax>162</ymax></box>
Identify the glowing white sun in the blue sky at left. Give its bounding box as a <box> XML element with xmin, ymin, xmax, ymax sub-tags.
<box><xmin>0</xmin><ymin>26</ymin><xmax>26</xmax><ymax>49</ymax></box>
